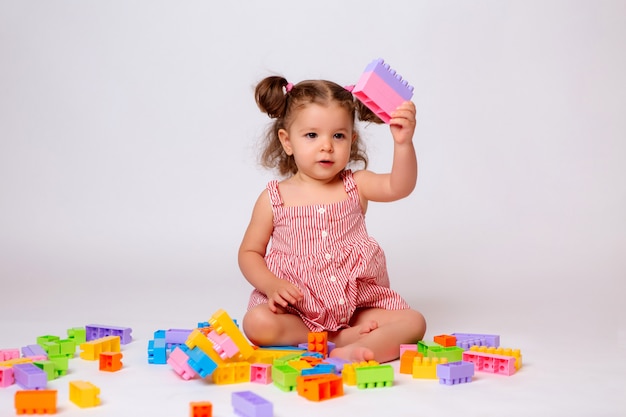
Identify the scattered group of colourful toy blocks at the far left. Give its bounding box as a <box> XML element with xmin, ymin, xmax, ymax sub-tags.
<box><xmin>0</xmin><ymin>325</ymin><xmax>132</xmax><ymax>414</ymax></box>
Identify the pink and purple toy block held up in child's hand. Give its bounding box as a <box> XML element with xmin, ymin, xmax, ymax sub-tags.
<box><xmin>352</xmin><ymin>58</ymin><xmax>413</xmax><ymax>123</ymax></box>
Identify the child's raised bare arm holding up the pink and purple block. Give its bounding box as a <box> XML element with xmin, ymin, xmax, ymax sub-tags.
<box><xmin>354</xmin><ymin>101</ymin><xmax>417</xmax><ymax>202</ymax></box>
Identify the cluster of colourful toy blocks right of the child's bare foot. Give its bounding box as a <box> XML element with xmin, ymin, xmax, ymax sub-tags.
<box><xmin>400</xmin><ymin>333</ymin><xmax>522</xmax><ymax>385</ymax></box>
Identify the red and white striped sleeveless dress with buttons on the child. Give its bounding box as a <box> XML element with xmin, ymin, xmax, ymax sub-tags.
<box><xmin>248</xmin><ymin>170</ymin><xmax>409</xmax><ymax>331</ymax></box>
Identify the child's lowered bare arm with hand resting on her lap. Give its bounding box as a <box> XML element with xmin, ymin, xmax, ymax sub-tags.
<box><xmin>238</xmin><ymin>191</ymin><xmax>302</xmax><ymax>312</ymax></box>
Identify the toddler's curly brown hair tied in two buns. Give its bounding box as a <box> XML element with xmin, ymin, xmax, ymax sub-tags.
<box><xmin>254</xmin><ymin>76</ymin><xmax>383</xmax><ymax>175</ymax></box>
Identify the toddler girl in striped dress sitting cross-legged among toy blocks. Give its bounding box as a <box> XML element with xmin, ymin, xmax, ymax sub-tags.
<box><xmin>239</xmin><ymin>76</ymin><xmax>426</xmax><ymax>362</ymax></box>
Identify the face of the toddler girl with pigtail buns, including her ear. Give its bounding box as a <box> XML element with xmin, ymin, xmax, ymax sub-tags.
<box><xmin>278</xmin><ymin>103</ymin><xmax>356</xmax><ymax>180</ymax></box>
